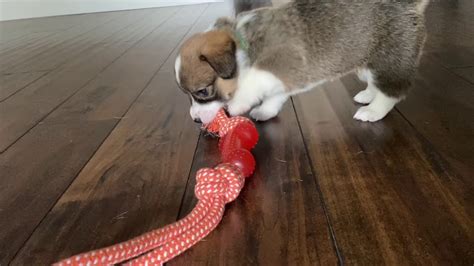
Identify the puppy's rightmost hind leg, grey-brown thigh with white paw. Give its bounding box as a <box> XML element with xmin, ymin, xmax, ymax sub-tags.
<box><xmin>354</xmin><ymin>16</ymin><xmax>425</xmax><ymax>122</ymax></box>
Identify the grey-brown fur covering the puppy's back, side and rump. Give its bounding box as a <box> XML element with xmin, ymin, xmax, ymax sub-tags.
<box><xmin>231</xmin><ymin>0</ymin><xmax>425</xmax><ymax>97</ymax></box>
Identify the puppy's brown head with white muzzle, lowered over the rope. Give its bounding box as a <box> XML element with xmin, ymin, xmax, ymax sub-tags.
<box><xmin>175</xmin><ymin>30</ymin><xmax>237</xmax><ymax>123</ymax></box>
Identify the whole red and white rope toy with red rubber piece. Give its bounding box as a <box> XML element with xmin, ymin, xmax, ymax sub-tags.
<box><xmin>54</xmin><ymin>110</ymin><xmax>258</xmax><ymax>266</ymax></box>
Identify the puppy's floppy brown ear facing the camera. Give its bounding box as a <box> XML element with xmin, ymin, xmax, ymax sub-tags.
<box><xmin>199</xmin><ymin>30</ymin><xmax>237</xmax><ymax>79</ymax></box>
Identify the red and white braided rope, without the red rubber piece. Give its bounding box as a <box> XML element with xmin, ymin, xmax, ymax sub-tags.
<box><xmin>55</xmin><ymin>111</ymin><xmax>254</xmax><ymax>266</ymax></box>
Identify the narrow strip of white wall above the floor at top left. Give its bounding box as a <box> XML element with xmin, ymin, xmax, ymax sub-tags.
<box><xmin>0</xmin><ymin>0</ymin><xmax>222</xmax><ymax>21</ymax></box>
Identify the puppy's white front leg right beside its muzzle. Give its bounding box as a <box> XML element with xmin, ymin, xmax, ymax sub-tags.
<box><xmin>227</xmin><ymin>67</ymin><xmax>285</xmax><ymax>116</ymax></box>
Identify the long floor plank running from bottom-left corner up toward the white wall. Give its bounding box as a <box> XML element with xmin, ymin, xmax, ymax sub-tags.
<box><xmin>0</xmin><ymin>7</ymin><xmax>190</xmax><ymax>264</ymax></box>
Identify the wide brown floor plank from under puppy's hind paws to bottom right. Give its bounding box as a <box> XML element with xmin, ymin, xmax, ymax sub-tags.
<box><xmin>295</xmin><ymin>75</ymin><xmax>474</xmax><ymax>265</ymax></box>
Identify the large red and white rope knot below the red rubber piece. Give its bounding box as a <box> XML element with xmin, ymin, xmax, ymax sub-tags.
<box><xmin>194</xmin><ymin>163</ymin><xmax>245</xmax><ymax>203</ymax></box>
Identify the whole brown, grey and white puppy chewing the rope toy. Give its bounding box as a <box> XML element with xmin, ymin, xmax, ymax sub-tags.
<box><xmin>175</xmin><ymin>0</ymin><xmax>429</xmax><ymax>123</ymax></box>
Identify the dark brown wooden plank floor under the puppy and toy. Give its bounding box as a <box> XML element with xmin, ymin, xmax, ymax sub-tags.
<box><xmin>0</xmin><ymin>0</ymin><xmax>474</xmax><ymax>265</ymax></box>
